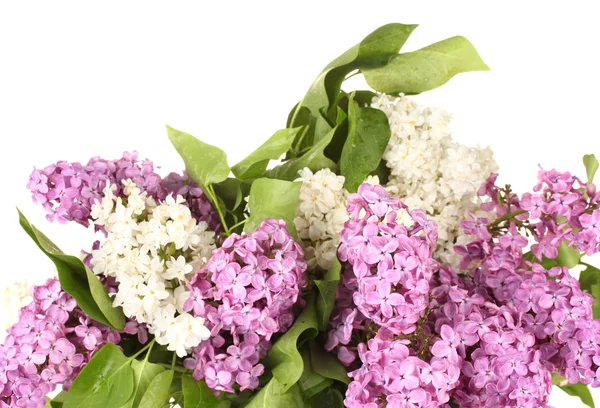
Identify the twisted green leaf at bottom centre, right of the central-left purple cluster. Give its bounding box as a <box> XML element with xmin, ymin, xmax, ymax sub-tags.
<box><xmin>265</xmin><ymin>298</ymin><xmax>318</xmax><ymax>392</ymax></box>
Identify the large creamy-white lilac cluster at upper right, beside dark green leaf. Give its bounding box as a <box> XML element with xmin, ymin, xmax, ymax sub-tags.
<box><xmin>371</xmin><ymin>94</ymin><xmax>498</xmax><ymax>267</ymax></box>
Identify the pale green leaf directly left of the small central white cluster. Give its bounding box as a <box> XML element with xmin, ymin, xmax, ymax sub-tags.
<box><xmin>244</xmin><ymin>178</ymin><xmax>302</xmax><ymax>236</ymax></box>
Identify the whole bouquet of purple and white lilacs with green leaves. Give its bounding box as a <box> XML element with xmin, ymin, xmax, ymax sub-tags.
<box><xmin>0</xmin><ymin>24</ymin><xmax>600</xmax><ymax>408</ymax></box>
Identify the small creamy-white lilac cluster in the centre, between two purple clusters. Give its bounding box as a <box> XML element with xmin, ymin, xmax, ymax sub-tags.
<box><xmin>294</xmin><ymin>168</ymin><xmax>348</xmax><ymax>270</ymax></box>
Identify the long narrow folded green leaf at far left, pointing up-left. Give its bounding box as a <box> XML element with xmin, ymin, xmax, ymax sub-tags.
<box><xmin>17</xmin><ymin>209</ymin><xmax>125</xmax><ymax>330</ymax></box>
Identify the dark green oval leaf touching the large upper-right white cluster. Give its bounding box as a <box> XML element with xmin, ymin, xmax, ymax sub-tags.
<box><xmin>340</xmin><ymin>95</ymin><xmax>391</xmax><ymax>193</ymax></box>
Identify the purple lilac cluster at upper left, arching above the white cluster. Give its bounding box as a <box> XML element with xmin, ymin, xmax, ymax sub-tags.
<box><xmin>27</xmin><ymin>152</ymin><xmax>219</xmax><ymax>230</ymax></box>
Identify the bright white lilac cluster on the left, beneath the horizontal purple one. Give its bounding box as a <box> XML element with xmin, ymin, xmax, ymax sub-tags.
<box><xmin>91</xmin><ymin>180</ymin><xmax>215</xmax><ymax>357</ymax></box>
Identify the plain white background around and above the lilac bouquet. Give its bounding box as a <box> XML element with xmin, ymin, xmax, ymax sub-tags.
<box><xmin>0</xmin><ymin>0</ymin><xmax>600</xmax><ymax>408</ymax></box>
